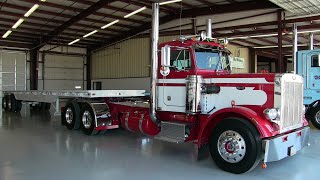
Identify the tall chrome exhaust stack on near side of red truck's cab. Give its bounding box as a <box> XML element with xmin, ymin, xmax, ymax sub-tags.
<box><xmin>150</xmin><ymin>3</ymin><xmax>160</xmax><ymax>125</ymax></box>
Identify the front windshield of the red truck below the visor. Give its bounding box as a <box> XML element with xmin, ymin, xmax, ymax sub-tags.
<box><xmin>195</xmin><ymin>49</ymin><xmax>230</xmax><ymax>70</ymax></box>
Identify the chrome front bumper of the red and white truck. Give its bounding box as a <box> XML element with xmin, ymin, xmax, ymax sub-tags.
<box><xmin>262</xmin><ymin>127</ymin><xmax>310</xmax><ymax>163</ymax></box>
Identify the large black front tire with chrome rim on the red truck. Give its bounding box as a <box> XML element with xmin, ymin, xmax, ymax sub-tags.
<box><xmin>209</xmin><ymin>118</ymin><xmax>262</xmax><ymax>174</ymax></box>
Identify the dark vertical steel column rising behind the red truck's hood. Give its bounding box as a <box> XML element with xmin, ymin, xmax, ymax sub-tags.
<box><xmin>277</xmin><ymin>10</ymin><xmax>284</xmax><ymax>73</ymax></box>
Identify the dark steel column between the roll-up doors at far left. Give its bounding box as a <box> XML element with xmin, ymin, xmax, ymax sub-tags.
<box><xmin>30</xmin><ymin>49</ymin><xmax>39</xmax><ymax>90</ymax></box>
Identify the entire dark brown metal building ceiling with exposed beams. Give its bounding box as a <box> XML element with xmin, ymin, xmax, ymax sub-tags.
<box><xmin>0</xmin><ymin>0</ymin><xmax>320</xmax><ymax>55</ymax></box>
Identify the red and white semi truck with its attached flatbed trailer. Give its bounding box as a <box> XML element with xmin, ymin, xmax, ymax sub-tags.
<box><xmin>4</xmin><ymin>3</ymin><xmax>310</xmax><ymax>174</ymax></box>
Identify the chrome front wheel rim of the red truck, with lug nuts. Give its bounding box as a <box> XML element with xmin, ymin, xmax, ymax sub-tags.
<box><xmin>217</xmin><ymin>130</ymin><xmax>246</xmax><ymax>163</ymax></box>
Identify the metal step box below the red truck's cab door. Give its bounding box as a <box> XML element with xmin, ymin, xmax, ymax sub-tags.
<box><xmin>154</xmin><ymin>121</ymin><xmax>190</xmax><ymax>143</ymax></box>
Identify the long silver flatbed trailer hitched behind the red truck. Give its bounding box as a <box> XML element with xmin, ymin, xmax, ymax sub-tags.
<box><xmin>2</xmin><ymin>90</ymin><xmax>149</xmax><ymax>115</ymax></box>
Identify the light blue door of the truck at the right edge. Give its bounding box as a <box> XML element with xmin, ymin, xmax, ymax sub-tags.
<box><xmin>305</xmin><ymin>51</ymin><xmax>320</xmax><ymax>89</ymax></box>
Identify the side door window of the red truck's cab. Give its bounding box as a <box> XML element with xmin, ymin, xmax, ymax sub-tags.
<box><xmin>170</xmin><ymin>49</ymin><xmax>191</xmax><ymax>70</ymax></box>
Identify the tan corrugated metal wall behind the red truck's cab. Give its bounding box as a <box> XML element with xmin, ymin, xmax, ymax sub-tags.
<box><xmin>92</xmin><ymin>36</ymin><xmax>249</xmax><ymax>80</ymax></box>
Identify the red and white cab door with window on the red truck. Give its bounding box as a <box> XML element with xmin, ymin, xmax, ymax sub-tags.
<box><xmin>158</xmin><ymin>47</ymin><xmax>192</xmax><ymax>112</ymax></box>
